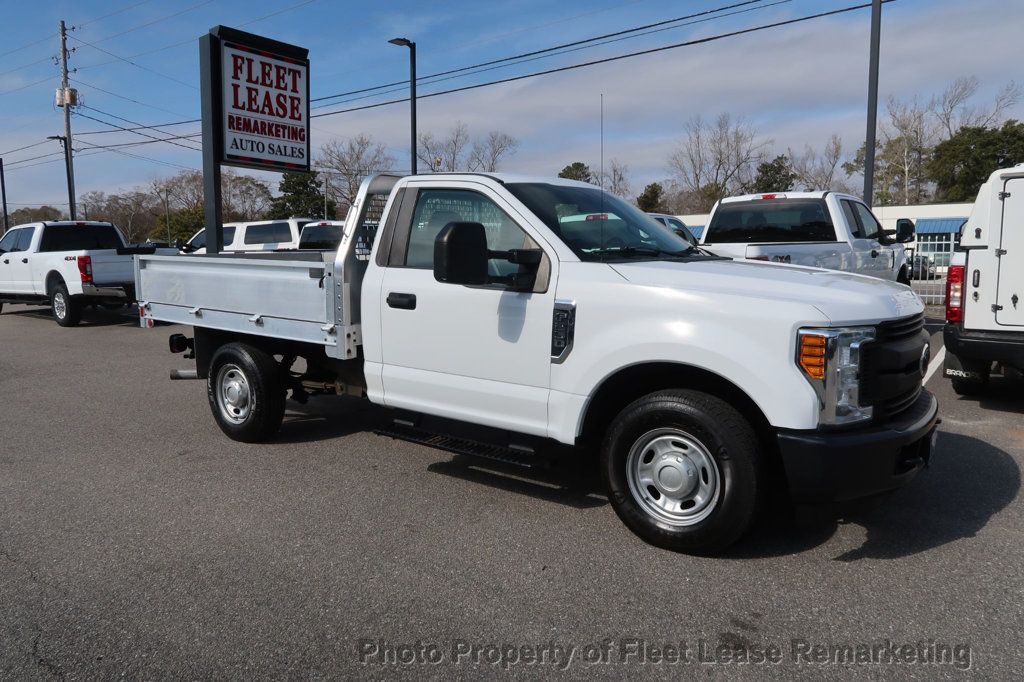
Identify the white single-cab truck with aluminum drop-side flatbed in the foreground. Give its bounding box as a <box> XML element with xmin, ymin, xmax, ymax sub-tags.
<box><xmin>136</xmin><ymin>174</ymin><xmax>938</xmax><ymax>553</ymax></box>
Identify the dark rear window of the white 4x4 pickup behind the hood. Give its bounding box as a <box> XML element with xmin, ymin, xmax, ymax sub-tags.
<box><xmin>705</xmin><ymin>199</ymin><xmax>836</xmax><ymax>244</ymax></box>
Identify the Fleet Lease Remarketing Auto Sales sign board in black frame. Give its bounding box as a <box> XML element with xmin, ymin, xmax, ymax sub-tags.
<box><xmin>203</xmin><ymin>27</ymin><xmax>309</xmax><ymax>171</ymax></box>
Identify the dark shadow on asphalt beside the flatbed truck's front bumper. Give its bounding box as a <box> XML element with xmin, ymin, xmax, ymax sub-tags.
<box><xmin>726</xmin><ymin>432</ymin><xmax>1021</xmax><ymax>562</ymax></box>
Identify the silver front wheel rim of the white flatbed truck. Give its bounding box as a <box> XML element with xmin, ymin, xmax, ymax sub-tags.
<box><xmin>626</xmin><ymin>428</ymin><xmax>722</xmax><ymax>526</ymax></box>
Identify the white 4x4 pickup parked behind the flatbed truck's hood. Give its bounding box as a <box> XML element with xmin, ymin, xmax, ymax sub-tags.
<box><xmin>700</xmin><ymin>191</ymin><xmax>913</xmax><ymax>285</ymax></box>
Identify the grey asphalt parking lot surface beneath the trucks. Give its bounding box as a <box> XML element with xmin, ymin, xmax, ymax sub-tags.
<box><xmin>0</xmin><ymin>306</ymin><xmax>1024</xmax><ymax>679</ymax></box>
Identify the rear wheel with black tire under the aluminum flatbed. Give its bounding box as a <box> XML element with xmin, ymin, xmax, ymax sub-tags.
<box><xmin>206</xmin><ymin>343</ymin><xmax>285</xmax><ymax>442</ymax></box>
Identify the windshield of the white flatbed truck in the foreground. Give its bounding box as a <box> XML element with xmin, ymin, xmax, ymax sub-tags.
<box><xmin>506</xmin><ymin>182</ymin><xmax>698</xmax><ymax>260</ymax></box>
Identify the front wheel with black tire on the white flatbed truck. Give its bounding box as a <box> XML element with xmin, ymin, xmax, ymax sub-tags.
<box><xmin>601</xmin><ymin>390</ymin><xmax>764</xmax><ymax>554</ymax></box>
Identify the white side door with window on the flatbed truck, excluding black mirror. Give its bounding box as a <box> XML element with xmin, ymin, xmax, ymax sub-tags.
<box><xmin>379</xmin><ymin>182</ymin><xmax>556</xmax><ymax>435</ymax></box>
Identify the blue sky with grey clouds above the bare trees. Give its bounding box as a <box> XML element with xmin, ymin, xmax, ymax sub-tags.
<box><xmin>0</xmin><ymin>0</ymin><xmax>1024</xmax><ymax>210</ymax></box>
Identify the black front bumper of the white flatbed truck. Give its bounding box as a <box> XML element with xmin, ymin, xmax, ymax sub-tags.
<box><xmin>778</xmin><ymin>390</ymin><xmax>939</xmax><ymax>502</ymax></box>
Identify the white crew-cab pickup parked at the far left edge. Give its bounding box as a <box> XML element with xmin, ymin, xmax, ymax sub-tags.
<box><xmin>0</xmin><ymin>221</ymin><xmax>169</xmax><ymax>327</ymax></box>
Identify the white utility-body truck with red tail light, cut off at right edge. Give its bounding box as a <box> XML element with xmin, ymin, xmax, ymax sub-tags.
<box><xmin>943</xmin><ymin>164</ymin><xmax>1024</xmax><ymax>394</ymax></box>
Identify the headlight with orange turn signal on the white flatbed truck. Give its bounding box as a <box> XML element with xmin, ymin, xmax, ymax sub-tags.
<box><xmin>797</xmin><ymin>327</ymin><xmax>874</xmax><ymax>425</ymax></box>
